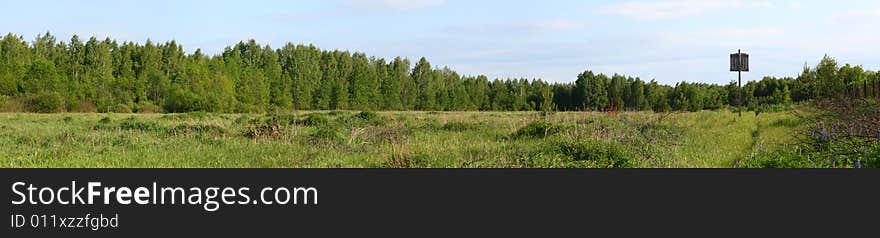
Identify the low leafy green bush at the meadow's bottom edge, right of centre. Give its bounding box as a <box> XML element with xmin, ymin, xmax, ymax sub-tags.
<box><xmin>557</xmin><ymin>140</ymin><xmax>634</xmax><ymax>168</ymax></box>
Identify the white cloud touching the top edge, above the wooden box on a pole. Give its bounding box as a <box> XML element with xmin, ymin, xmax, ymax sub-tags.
<box><xmin>598</xmin><ymin>0</ymin><xmax>773</xmax><ymax>20</ymax></box>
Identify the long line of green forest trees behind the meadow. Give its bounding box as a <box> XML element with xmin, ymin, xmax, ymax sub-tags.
<box><xmin>0</xmin><ymin>33</ymin><xmax>880</xmax><ymax>113</ymax></box>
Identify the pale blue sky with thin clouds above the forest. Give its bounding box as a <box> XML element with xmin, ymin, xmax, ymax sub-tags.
<box><xmin>0</xmin><ymin>0</ymin><xmax>880</xmax><ymax>85</ymax></box>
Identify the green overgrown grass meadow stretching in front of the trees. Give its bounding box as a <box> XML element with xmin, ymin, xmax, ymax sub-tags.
<box><xmin>0</xmin><ymin>111</ymin><xmax>801</xmax><ymax>168</ymax></box>
